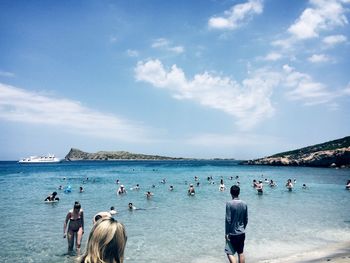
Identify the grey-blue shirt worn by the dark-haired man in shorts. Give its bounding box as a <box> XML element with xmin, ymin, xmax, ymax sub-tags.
<box><xmin>225</xmin><ymin>198</ymin><xmax>248</xmax><ymax>235</ymax></box>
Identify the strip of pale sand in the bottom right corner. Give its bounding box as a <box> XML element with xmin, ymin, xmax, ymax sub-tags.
<box><xmin>259</xmin><ymin>241</ymin><xmax>350</xmax><ymax>263</ymax></box>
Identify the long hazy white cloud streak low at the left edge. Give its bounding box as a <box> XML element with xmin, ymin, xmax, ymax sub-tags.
<box><xmin>0</xmin><ymin>83</ymin><xmax>151</xmax><ymax>142</ymax></box>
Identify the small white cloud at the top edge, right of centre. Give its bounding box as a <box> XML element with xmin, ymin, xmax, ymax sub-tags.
<box><xmin>208</xmin><ymin>0</ymin><xmax>263</xmax><ymax>30</ymax></box>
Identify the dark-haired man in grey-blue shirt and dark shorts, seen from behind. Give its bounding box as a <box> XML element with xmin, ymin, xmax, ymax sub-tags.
<box><xmin>225</xmin><ymin>185</ymin><xmax>248</xmax><ymax>263</ymax></box>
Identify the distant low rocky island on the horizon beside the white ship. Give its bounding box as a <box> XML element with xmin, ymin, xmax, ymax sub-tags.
<box><xmin>65</xmin><ymin>148</ymin><xmax>184</xmax><ymax>161</ymax></box>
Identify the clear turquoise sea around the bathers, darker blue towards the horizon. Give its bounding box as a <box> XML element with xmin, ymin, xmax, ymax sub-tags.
<box><xmin>0</xmin><ymin>160</ymin><xmax>350</xmax><ymax>263</ymax></box>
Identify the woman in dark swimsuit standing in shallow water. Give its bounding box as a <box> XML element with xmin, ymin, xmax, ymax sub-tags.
<box><xmin>63</xmin><ymin>202</ymin><xmax>84</xmax><ymax>252</ymax></box>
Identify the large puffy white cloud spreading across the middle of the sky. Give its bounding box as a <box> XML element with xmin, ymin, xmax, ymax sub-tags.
<box><xmin>135</xmin><ymin>60</ymin><xmax>280</xmax><ymax>129</ymax></box>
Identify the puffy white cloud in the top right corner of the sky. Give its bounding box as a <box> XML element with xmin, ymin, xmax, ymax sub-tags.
<box><xmin>288</xmin><ymin>0</ymin><xmax>348</xmax><ymax>39</ymax></box>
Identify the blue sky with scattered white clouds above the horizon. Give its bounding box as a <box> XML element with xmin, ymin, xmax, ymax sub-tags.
<box><xmin>0</xmin><ymin>0</ymin><xmax>350</xmax><ymax>160</ymax></box>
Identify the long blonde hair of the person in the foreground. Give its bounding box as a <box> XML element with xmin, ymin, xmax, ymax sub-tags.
<box><xmin>80</xmin><ymin>218</ymin><xmax>127</xmax><ymax>263</ymax></box>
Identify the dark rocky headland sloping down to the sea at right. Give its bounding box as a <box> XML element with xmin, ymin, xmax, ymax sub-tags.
<box><xmin>242</xmin><ymin>136</ymin><xmax>350</xmax><ymax>168</ymax></box>
